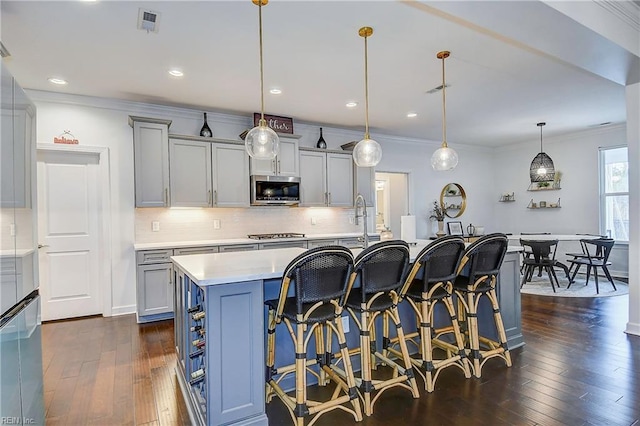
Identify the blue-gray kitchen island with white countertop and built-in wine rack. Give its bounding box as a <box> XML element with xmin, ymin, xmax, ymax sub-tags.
<box><xmin>171</xmin><ymin>241</ymin><xmax>524</xmax><ymax>425</ymax></box>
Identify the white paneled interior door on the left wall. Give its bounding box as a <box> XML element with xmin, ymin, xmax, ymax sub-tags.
<box><xmin>38</xmin><ymin>150</ymin><xmax>103</xmax><ymax>321</ymax></box>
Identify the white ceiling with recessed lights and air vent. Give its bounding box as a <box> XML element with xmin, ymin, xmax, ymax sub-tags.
<box><xmin>0</xmin><ymin>0</ymin><xmax>640</xmax><ymax>147</ymax></box>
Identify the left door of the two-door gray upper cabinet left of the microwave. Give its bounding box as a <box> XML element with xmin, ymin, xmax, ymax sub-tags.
<box><xmin>169</xmin><ymin>138</ymin><xmax>212</xmax><ymax>207</ymax></box>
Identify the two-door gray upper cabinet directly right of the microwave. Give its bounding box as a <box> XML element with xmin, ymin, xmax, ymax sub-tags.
<box><xmin>300</xmin><ymin>150</ymin><xmax>353</xmax><ymax>207</ymax></box>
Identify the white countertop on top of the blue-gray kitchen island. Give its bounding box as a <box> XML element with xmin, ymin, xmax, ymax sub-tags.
<box><xmin>171</xmin><ymin>240</ymin><xmax>522</xmax><ymax>287</ymax></box>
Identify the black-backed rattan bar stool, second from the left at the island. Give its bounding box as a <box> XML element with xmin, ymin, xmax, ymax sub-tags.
<box><xmin>346</xmin><ymin>240</ymin><xmax>419</xmax><ymax>416</ymax></box>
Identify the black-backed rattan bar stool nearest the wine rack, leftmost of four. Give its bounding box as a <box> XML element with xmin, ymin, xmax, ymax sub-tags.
<box><xmin>265</xmin><ymin>246</ymin><xmax>362</xmax><ymax>426</ymax></box>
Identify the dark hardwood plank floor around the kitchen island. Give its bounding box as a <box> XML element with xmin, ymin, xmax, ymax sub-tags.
<box><xmin>43</xmin><ymin>295</ymin><xmax>640</xmax><ymax>426</ymax></box>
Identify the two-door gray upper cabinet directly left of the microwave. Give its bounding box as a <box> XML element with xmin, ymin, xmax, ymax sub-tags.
<box><xmin>169</xmin><ymin>137</ymin><xmax>249</xmax><ymax>207</ymax></box>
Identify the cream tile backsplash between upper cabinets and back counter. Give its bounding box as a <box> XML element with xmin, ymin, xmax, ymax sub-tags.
<box><xmin>135</xmin><ymin>207</ymin><xmax>373</xmax><ymax>243</ymax></box>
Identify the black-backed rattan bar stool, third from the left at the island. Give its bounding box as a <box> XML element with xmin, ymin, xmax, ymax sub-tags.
<box><xmin>387</xmin><ymin>236</ymin><xmax>471</xmax><ymax>392</ymax></box>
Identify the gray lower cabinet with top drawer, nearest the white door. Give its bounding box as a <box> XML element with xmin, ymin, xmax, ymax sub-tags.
<box><xmin>136</xmin><ymin>249</ymin><xmax>174</xmax><ymax>323</ymax></box>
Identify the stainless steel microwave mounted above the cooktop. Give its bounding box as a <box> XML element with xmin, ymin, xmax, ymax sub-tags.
<box><xmin>251</xmin><ymin>175</ymin><xmax>300</xmax><ymax>206</ymax></box>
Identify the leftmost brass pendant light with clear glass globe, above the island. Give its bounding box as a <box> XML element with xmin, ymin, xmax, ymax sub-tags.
<box><xmin>244</xmin><ymin>0</ymin><xmax>280</xmax><ymax>160</ymax></box>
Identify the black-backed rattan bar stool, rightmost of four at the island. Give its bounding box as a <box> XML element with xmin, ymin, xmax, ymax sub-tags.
<box><xmin>453</xmin><ymin>234</ymin><xmax>511</xmax><ymax>377</ymax></box>
